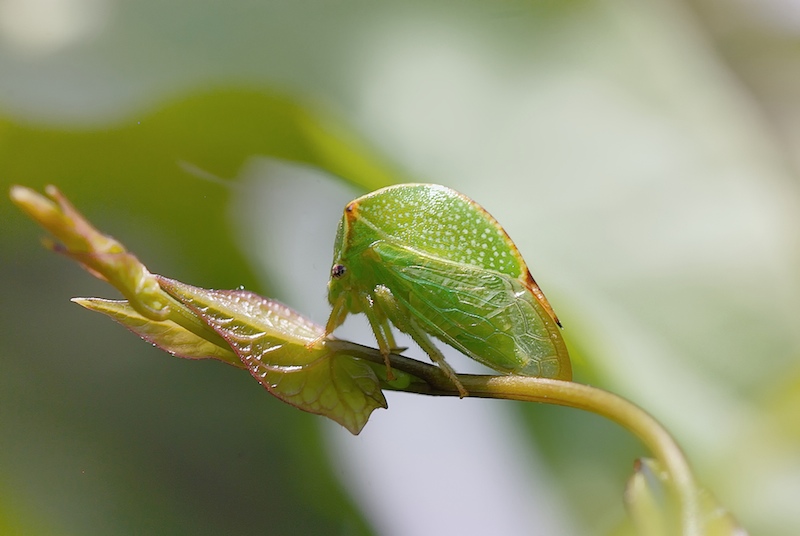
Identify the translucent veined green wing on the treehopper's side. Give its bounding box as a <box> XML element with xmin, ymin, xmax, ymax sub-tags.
<box><xmin>371</xmin><ymin>241</ymin><xmax>572</xmax><ymax>380</ymax></box>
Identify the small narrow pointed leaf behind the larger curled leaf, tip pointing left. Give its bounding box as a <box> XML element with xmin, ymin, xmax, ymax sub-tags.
<box><xmin>72</xmin><ymin>298</ymin><xmax>245</xmax><ymax>368</ymax></box>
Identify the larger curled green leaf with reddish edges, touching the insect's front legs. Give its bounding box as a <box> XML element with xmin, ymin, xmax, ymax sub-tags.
<box><xmin>159</xmin><ymin>277</ymin><xmax>386</xmax><ymax>434</ymax></box>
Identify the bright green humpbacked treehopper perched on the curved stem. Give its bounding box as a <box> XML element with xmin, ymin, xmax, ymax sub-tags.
<box><xmin>325</xmin><ymin>184</ymin><xmax>572</xmax><ymax>397</ymax></box>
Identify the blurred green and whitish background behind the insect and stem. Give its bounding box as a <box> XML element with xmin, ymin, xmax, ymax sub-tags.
<box><xmin>0</xmin><ymin>0</ymin><xmax>800</xmax><ymax>535</ymax></box>
